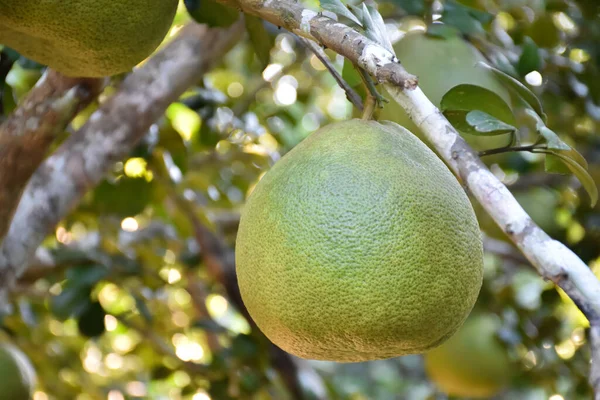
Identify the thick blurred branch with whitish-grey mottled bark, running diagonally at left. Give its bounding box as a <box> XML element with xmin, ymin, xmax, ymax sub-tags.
<box><xmin>0</xmin><ymin>24</ymin><xmax>242</xmax><ymax>289</ymax></box>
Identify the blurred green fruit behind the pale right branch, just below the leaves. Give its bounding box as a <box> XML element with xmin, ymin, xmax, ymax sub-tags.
<box><xmin>473</xmin><ymin>187</ymin><xmax>561</xmax><ymax>241</ymax></box>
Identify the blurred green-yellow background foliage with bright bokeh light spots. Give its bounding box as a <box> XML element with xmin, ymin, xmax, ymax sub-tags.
<box><xmin>0</xmin><ymin>0</ymin><xmax>600</xmax><ymax>400</ymax></box>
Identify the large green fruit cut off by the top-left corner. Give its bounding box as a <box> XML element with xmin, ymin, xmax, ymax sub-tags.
<box><xmin>0</xmin><ymin>0</ymin><xmax>178</xmax><ymax>77</ymax></box>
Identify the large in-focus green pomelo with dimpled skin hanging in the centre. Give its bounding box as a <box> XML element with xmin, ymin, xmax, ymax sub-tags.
<box><xmin>236</xmin><ymin>119</ymin><xmax>483</xmax><ymax>362</ymax></box>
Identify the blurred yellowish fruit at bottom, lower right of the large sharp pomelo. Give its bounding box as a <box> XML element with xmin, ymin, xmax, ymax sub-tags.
<box><xmin>425</xmin><ymin>314</ymin><xmax>510</xmax><ymax>398</ymax></box>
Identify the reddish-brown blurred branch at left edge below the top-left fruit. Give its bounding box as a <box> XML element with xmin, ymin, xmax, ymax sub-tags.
<box><xmin>0</xmin><ymin>70</ymin><xmax>103</xmax><ymax>242</ymax></box>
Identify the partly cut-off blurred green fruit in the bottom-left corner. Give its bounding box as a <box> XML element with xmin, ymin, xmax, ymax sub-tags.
<box><xmin>0</xmin><ymin>343</ymin><xmax>36</xmax><ymax>400</ymax></box>
